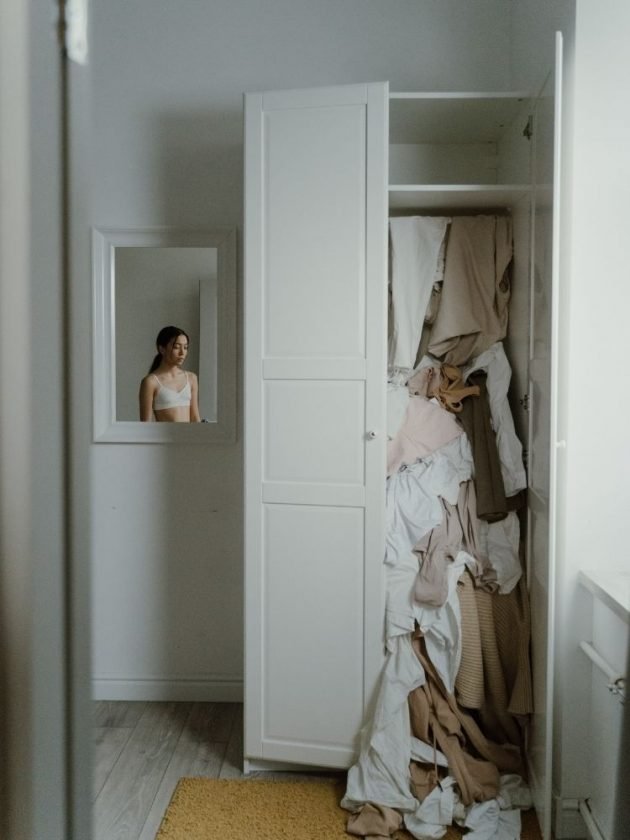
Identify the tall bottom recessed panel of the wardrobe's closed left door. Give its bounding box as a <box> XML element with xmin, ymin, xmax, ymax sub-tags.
<box><xmin>262</xmin><ymin>505</ymin><xmax>364</xmax><ymax>754</ymax></box>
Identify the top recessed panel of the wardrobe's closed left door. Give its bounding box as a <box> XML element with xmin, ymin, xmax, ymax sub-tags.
<box><xmin>263</xmin><ymin>103</ymin><xmax>366</xmax><ymax>357</ymax></box>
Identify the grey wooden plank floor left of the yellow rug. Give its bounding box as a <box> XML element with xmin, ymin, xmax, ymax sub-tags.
<box><xmin>93</xmin><ymin>700</ymin><xmax>249</xmax><ymax>840</ymax></box>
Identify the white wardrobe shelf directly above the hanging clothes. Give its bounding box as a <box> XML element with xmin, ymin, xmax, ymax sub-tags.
<box><xmin>389</xmin><ymin>184</ymin><xmax>531</xmax><ymax>210</ymax></box>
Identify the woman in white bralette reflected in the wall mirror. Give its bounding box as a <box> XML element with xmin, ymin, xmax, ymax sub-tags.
<box><xmin>140</xmin><ymin>327</ymin><xmax>201</xmax><ymax>423</ymax></box>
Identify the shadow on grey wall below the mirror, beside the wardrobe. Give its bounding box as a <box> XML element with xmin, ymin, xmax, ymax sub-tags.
<box><xmin>159</xmin><ymin>445</ymin><xmax>243</xmax><ymax>699</ymax></box>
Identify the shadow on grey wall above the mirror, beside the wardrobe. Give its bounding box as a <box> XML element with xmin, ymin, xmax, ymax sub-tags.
<box><xmin>148</xmin><ymin>111</ymin><xmax>243</xmax><ymax>227</ymax></box>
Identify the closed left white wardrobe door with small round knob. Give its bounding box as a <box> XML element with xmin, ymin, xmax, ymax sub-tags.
<box><xmin>245</xmin><ymin>84</ymin><xmax>387</xmax><ymax>767</ymax></box>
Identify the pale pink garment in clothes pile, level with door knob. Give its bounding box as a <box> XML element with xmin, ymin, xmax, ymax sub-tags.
<box><xmin>387</xmin><ymin>396</ymin><xmax>463</xmax><ymax>475</ymax></box>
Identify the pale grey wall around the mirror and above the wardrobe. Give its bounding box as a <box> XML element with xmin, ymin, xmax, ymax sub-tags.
<box><xmin>92</xmin><ymin>0</ymin><xmax>512</xmax><ymax>698</ymax></box>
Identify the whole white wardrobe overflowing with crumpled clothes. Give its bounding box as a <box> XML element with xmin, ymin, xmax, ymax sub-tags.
<box><xmin>245</xmin><ymin>79</ymin><xmax>553</xmax><ymax>837</ymax></box>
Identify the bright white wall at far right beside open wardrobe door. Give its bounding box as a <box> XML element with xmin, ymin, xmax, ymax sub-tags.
<box><xmin>512</xmin><ymin>0</ymin><xmax>630</xmax><ymax>838</ymax></box>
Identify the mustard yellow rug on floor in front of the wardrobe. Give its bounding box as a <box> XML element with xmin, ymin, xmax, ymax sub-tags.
<box><xmin>155</xmin><ymin>779</ymin><xmax>540</xmax><ymax>840</ymax></box>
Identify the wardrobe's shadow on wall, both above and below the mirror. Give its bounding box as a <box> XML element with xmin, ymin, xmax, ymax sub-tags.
<box><xmin>150</xmin><ymin>108</ymin><xmax>243</xmax><ymax>694</ymax></box>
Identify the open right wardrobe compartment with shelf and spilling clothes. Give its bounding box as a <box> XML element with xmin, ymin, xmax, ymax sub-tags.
<box><xmin>342</xmin><ymin>94</ymin><xmax>534</xmax><ymax>840</ymax></box>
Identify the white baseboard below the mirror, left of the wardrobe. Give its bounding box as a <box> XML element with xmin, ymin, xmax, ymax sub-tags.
<box><xmin>92</xmin><ymin>677</ymin><xmax>243</xmax><ymax>703</ymax></box>
